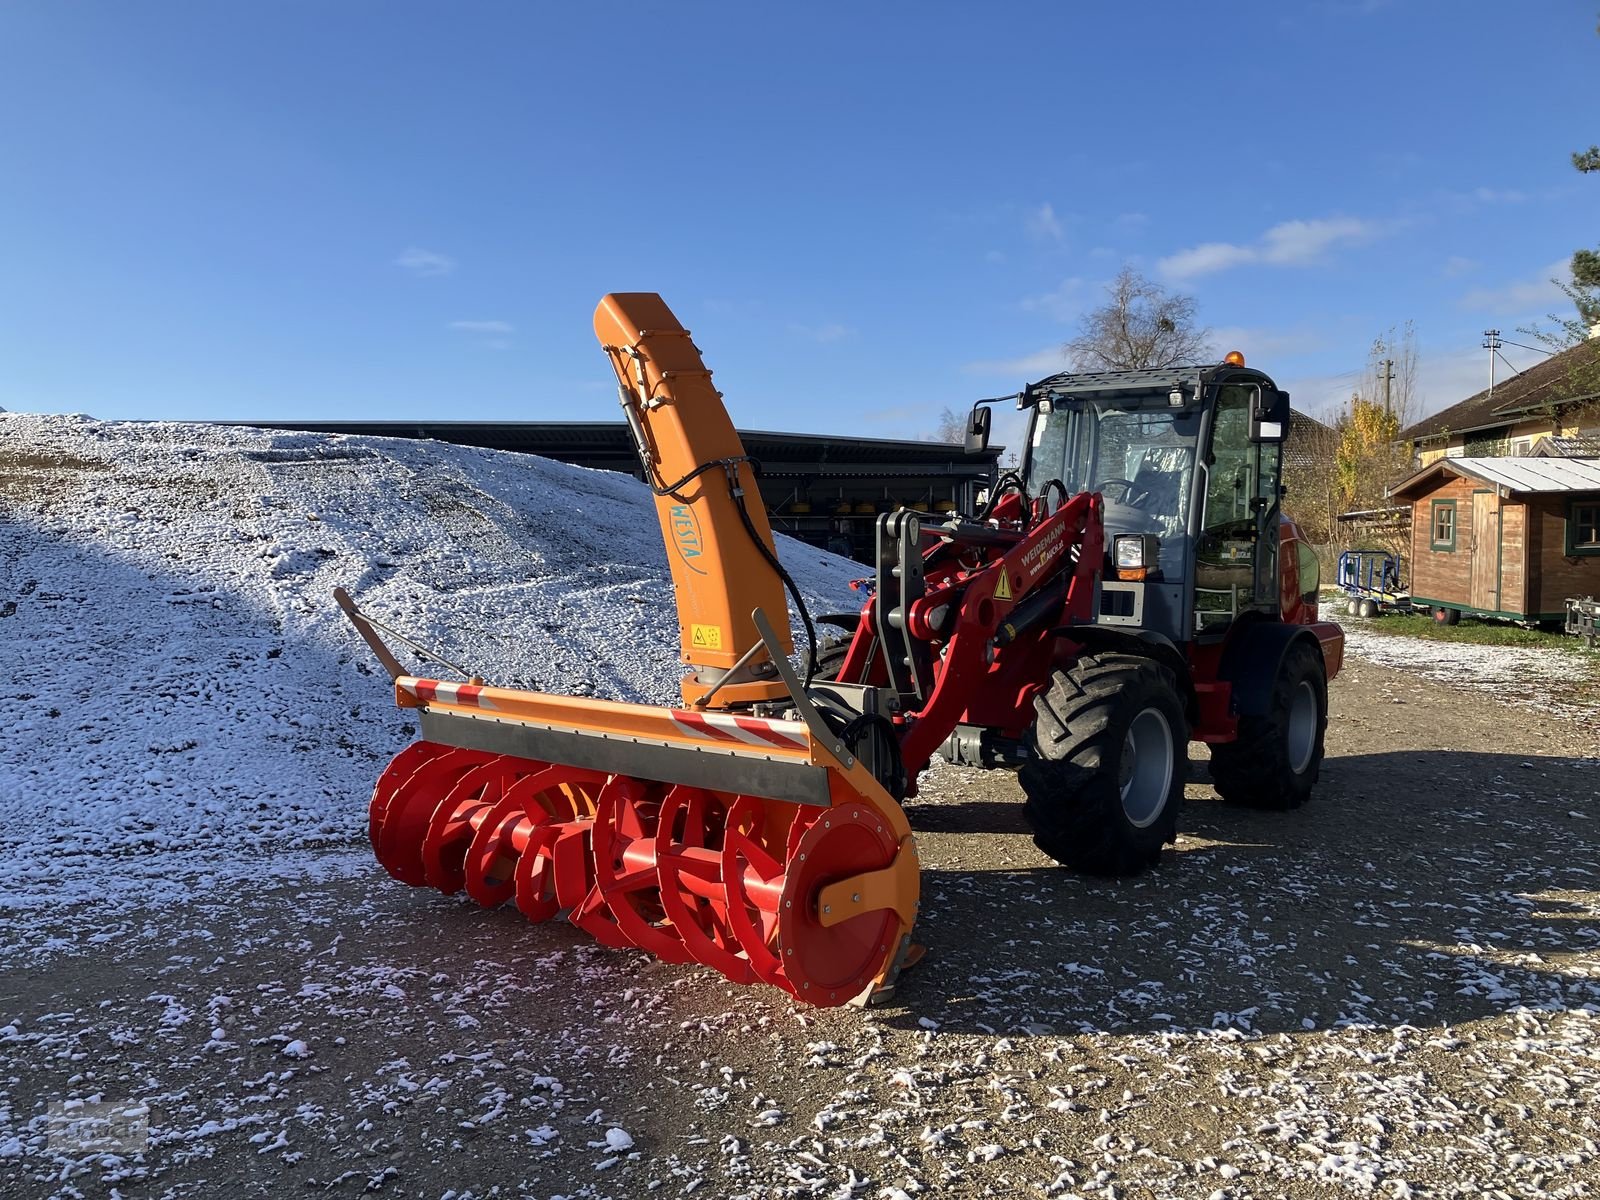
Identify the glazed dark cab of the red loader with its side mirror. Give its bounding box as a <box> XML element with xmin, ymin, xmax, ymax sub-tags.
<box><xmin>1021</xmin><ymin>363</ymin><xmax>1288</xmax><ymax>642</ymax></box>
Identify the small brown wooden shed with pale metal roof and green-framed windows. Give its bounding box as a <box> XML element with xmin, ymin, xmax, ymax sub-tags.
<box><xmin>1389</xmin><ymin>458</ymin><xmax>1600</xmax><ymax>622</ymax></box>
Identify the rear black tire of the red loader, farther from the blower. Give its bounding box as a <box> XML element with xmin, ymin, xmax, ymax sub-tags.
<box><xmin>1211</xmin><ymin>643</ymin><xmax>1328</xmax><ymax>811</ymax></box>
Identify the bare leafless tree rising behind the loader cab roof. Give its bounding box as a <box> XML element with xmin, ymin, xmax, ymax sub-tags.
<box><xmin>1064</xmin><ymin>267</ymin><xmax>1210</xmax><ymax>371</ymax></box>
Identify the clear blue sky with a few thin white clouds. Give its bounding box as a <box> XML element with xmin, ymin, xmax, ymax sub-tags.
<box><xmin>0</xmin><ymin>0</ymin><xmax>1600</xmax><ymax>437</ymax></box>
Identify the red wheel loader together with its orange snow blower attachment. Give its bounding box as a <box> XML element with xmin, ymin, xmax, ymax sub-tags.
<box><xmin>336</xmin><ymin>293</ymin><xmax>1344</xmax><ymax>1006</ymax></box>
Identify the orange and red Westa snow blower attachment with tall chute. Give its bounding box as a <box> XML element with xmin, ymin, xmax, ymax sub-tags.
<box><xmin>336</xmin><ymin>294</ymin><xmax>918</xmax><ymax>1005</ymax></box>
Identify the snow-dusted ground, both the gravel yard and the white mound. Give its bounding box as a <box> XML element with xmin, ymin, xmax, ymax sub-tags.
<box><xmin>0</xmin><ymin>414</ymin><xmax>1600</xmax><ymax>1200</ymax></box>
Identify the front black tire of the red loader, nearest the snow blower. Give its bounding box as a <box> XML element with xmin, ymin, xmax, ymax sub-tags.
<box><xmin>1018</xmin><ymin>654</ymin><xmax>1189</xmax><ymax>875</ymax></box>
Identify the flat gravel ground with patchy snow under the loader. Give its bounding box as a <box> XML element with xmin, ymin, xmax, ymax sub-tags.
<box><xmin>0</xmin><ymin>659</ymin><xmax>1600</xmax><ymax>1200</ymax></box>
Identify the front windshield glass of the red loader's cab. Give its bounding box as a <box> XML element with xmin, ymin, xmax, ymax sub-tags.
<box><xmin>1027</xmin><ymin>400</ymin><xmax>1200</xmax><ymax>538</ymax></box>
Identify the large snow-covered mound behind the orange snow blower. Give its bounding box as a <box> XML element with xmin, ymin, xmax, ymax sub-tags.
<box><xmin>0</xmin><ymin>413</ymin><xmax>861</xmax><ymax>923</ymax></box>
